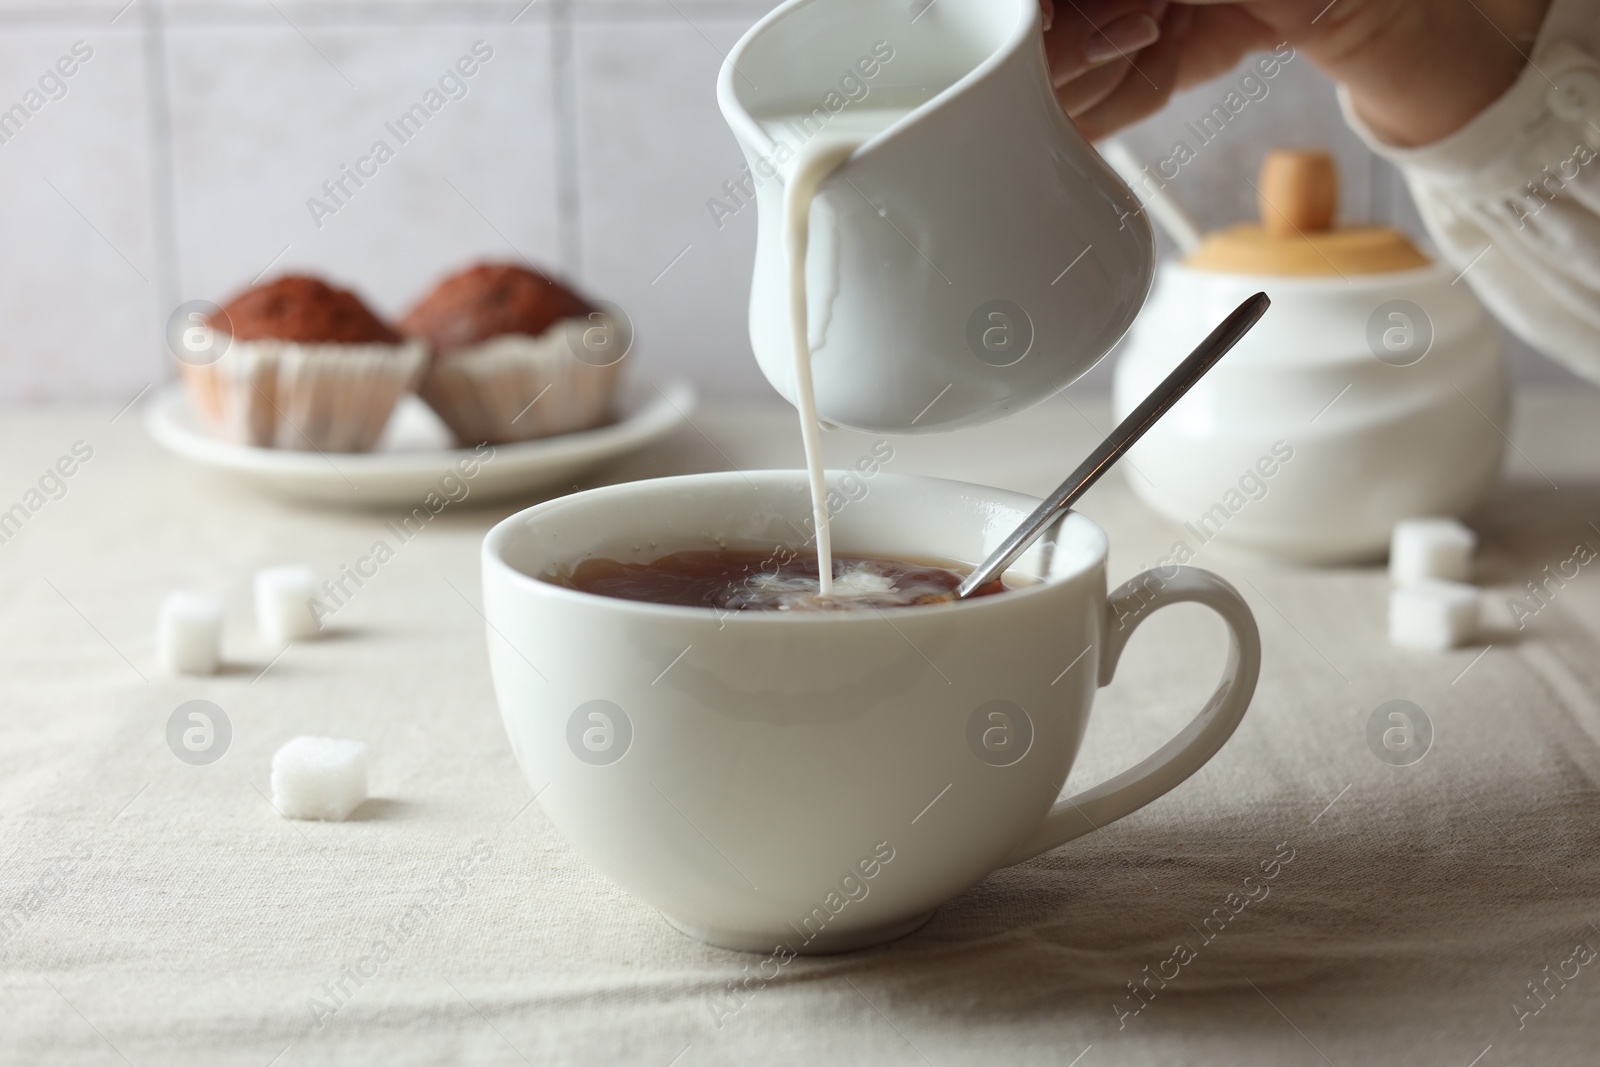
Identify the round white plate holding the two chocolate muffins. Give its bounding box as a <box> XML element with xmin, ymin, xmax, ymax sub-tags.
<box><xmin>144</xmin><ymin>381</ymin><xmax>694</xmax><ymax>507</ymax></box>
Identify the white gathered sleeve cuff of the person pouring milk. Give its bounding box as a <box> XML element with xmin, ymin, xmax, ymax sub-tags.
<box><xmin>1339</xmin><ymin>0</ymin><xmax>1600</xmax><ymax>382</ymax></box>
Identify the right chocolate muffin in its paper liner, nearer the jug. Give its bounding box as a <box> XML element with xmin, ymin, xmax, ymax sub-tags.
<box><xmin>400</xmin><ymin>264</ymin><xmax>629</xmax><ymax>445</ymax></box>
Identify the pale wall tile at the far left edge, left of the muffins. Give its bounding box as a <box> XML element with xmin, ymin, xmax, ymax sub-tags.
<box><xmin>0</xmin><ymin>16</ymin><xmax>163</xmax><ymax>402</ymax></box>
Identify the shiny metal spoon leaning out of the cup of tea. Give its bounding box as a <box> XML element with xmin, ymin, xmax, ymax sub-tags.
<box><xmin>955</xmin><ymin>293</ymin><xmax>1272</xmax><ymax>600</ymax></box>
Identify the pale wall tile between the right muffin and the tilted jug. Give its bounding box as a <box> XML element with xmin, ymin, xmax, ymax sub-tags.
<box><xmin>573</xmin><ymin>13</ymin><xmax>768</xmax><ymax>394</ymax></box>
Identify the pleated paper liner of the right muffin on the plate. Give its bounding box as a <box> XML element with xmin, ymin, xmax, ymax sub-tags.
<box><xmin>418</xmin><ymin>318</ymin><xmax>621</xmax><ymax>446</ymax></box>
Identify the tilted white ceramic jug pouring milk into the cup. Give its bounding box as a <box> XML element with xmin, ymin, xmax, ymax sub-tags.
<box><xmin>717</xmin><ymin>0</ymin><xmax>1155</xmax><ymax>434</ymax></box>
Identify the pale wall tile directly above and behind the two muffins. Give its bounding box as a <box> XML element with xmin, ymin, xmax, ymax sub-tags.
<box><xmin>166</xmin><ymin>18</ymin><xmax>557</xmax><ymax>321</ymax></box>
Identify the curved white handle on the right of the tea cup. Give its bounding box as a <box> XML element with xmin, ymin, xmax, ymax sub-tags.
<box><xmin>1000</xmin><ymin>566</ymin><xmax>1261</xmax><ymax>867</ymax></box>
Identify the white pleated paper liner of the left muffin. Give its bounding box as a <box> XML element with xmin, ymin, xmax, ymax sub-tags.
<box><xmin>178</xmin><ymin>341</ymin><xmax>427</xmax><ymax>453</ymax></box>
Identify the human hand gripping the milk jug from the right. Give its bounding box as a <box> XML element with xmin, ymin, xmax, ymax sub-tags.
<box><xmin>1042</xmin><ymin>0</ymin><xmax>1550</xmax><ymax>146</ymax></box>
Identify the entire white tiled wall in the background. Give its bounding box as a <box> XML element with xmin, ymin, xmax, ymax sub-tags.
<box><xmin>0</xmin><ymin>0</ymin><xmax>1580</xmax><ymax>403</ymax></box>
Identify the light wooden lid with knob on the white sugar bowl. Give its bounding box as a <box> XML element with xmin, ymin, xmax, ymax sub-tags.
<box><xmin>1184</xmin><ymin>149</ymin><xmax>1432</xmax><ymax>277</ymax></box>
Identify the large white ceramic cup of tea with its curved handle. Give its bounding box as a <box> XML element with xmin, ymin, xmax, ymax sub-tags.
<box><xmin>483</xmin><ymin>470</ymin><xmax>1261</xmax><ymax>952</ymax></box>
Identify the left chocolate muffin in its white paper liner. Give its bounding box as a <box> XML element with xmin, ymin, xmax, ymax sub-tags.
<box><xmin>179</xmin><ymin>277</ymin><xmax>427</xmax><ymax>453</ymax></box>
